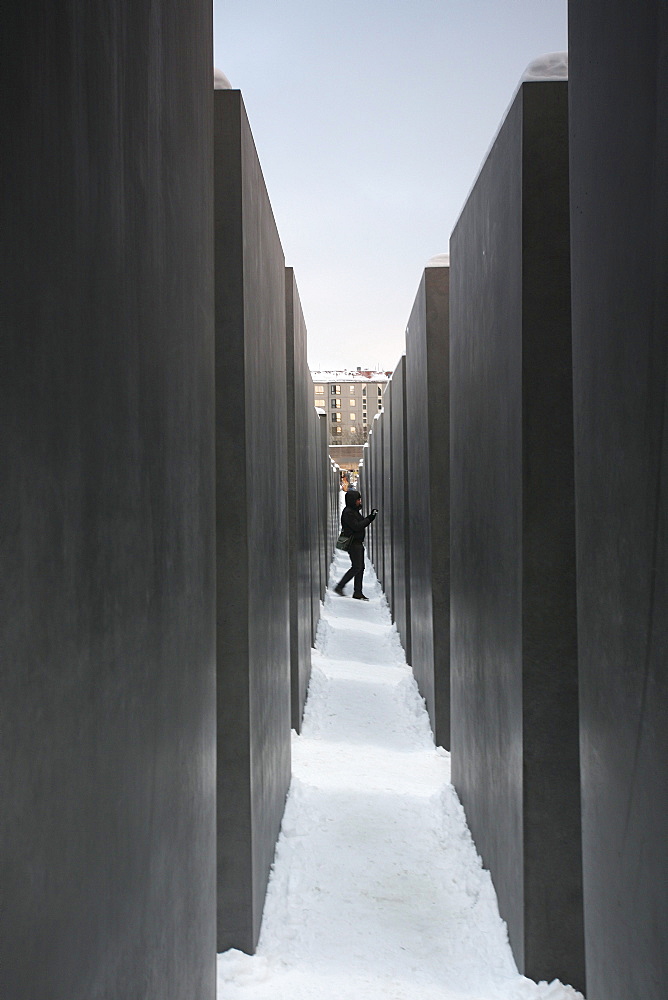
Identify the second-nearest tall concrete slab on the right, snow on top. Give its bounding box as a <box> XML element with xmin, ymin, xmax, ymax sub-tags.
<box><xmin>450</xmin><ymin>82</ymin><xmax>584</xmax><ymax>989</ymax></box>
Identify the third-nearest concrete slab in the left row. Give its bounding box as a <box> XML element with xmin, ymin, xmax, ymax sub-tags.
<box><xmin>278</xmin><ymin>267</ymin><xmax>317</xmax><ymax>732</ymax></box>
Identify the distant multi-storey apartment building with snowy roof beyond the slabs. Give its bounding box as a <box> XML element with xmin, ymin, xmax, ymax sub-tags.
<box><xmin>311</xmin><ymin>368</ymin><xmax>392</xmax><ymax>446</ymax></box>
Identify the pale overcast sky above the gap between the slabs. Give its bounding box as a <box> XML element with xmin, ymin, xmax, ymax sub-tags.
<box><xmin>214</xmin><ymin>0</ymin><xmax>567</xmax><ymax>369</ymax></box>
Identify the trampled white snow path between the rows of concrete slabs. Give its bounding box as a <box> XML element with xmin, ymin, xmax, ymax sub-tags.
<box><xmin>218</xmin><ymin>553</ymin><xmax>580</xmax><ymax>1000</ymax></box>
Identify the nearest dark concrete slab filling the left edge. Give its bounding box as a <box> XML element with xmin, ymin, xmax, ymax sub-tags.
<box><xmin>0</xmin><ymin>0</ymin><xmax>215</xmax><ymax>1000</ymax></box>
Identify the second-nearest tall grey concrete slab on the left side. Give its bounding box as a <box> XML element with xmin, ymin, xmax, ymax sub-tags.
<box><xmin>214</xmin><ymin>90</ymin><xmax>290</xmax><ymax>952</ymax></box>
